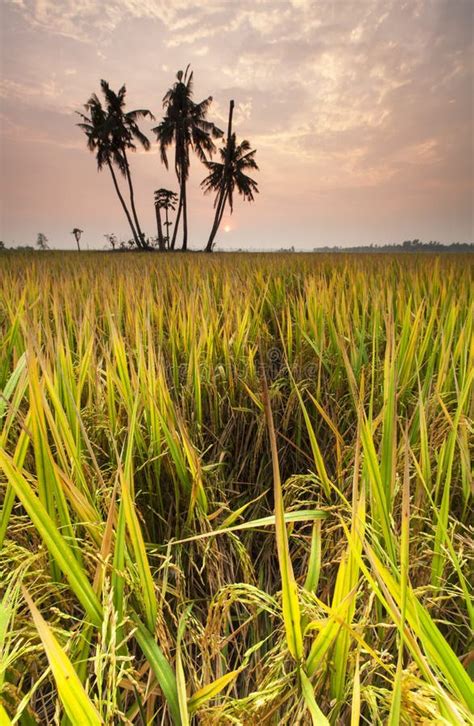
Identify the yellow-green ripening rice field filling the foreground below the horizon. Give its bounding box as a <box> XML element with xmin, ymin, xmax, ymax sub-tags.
<box><xmin>0</xmin><ymin>253</ymin><xmax>474</xmax><ymax>726</ymax></box>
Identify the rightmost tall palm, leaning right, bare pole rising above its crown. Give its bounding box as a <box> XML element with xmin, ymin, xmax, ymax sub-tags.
<box><xmin>201</xmin><ymin>112</ymin><xmax>258</xmax><ymax>252</ymax></box>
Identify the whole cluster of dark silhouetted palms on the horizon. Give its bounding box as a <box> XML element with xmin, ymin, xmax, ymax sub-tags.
<box><xmin>78</xmin><ymin>66</ymin><xmax>258</xmax><ymax>252</ymax></box>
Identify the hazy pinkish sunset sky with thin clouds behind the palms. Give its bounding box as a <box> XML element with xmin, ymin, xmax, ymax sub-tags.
<box><xmin>0</xmin><ymin>0</ymin><xmax>474</xmax><ymax>249</ymax></box>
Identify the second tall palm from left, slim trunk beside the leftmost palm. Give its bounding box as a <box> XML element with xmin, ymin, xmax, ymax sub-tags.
<box><xmin>100</xmin><ymin>80</ymin><xmax>155</xmax><ymax>246</ymax></box>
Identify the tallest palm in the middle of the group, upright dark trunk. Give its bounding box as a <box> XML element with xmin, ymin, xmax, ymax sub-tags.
<box><xmin>153</xmin><ymin>66</ymin><xmax>222</xmax><ymax>250</ymax></box>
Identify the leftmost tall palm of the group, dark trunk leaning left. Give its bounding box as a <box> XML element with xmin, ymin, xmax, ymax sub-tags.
<box><xmin>77</xmin><ymin>93</ymin><xmax>144</xmax><ymax>247</ymax></box>
